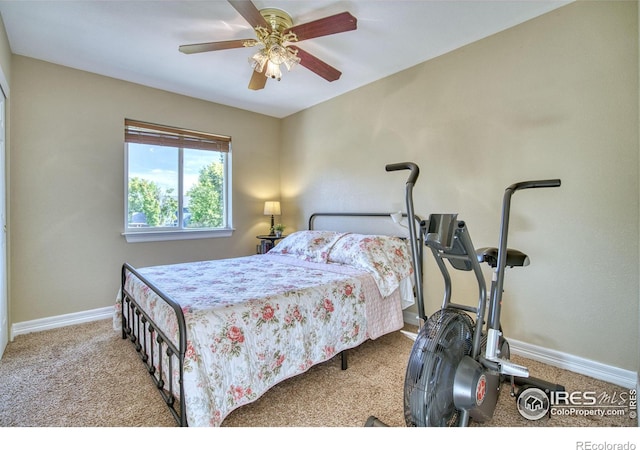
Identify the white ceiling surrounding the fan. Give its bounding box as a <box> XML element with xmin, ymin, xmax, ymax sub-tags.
<box><xmin>0</xmin><ymin>0</ymin><xmax>570</xmax><ymax>118</ymax></box>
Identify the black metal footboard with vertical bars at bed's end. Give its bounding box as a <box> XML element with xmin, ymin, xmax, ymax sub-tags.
<box><xmin>121</xmin><ymin>263</ymin><xmax>188</xmax><ymax>427</ymax></box>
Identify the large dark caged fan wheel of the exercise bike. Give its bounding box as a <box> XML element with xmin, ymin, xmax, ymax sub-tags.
<box><xmin>404</xmin><ymin>309</ymin><xmax>473</xmax><ymax>427</ymax></box>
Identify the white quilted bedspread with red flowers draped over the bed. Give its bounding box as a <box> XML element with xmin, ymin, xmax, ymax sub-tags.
<box><xmin>114</xmin><ymin>254</ymin><xmax>406</xmax><ymax>426</ymax></box>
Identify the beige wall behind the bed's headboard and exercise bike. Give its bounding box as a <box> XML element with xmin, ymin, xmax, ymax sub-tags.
<box><xmin>281</xmin><ymin>2</ymin><xmax>639</xmax><ymax>371</ymax></box>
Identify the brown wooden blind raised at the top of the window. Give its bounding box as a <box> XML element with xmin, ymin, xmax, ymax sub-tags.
<box><xmin>124</xmin><ymin>119</ymin><xmax>231</xmax><ymax>152</ymax></box>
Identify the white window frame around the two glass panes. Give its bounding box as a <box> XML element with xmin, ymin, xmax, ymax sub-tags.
<box><xmin>122</xmin><ymin>119</ymin><xmax>235</xmax><ymax>243</ymax></box>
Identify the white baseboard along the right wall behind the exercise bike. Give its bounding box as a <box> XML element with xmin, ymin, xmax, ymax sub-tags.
<box><xmin>403</xmin><ymin>311</ymin><xmax>640</xmax><ymax>390</ymax></box>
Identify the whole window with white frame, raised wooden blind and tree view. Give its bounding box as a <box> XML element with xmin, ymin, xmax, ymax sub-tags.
<box><xmin>124</xmin><ymin>119</ymin><xmax>232</xmax><ymax>242</ymax></box>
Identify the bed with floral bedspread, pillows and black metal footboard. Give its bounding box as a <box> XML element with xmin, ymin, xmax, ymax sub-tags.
<box><xmin>114</xmin><ymin>213</ymin><xmax>415</xmax><ymax>426</ymax></box>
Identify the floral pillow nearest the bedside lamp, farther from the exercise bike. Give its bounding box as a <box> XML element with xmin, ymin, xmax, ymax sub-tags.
<box><xmin>269</xmin><ymin>230</ymin><xmax>344</xmax><ymax>263</ymax></box>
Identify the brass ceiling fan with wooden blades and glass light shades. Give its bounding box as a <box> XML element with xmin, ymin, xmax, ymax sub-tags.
<box><xmin>179</xmin><ymin>0</ymin><xmax>357</xmax><ymax>90</ymax></box>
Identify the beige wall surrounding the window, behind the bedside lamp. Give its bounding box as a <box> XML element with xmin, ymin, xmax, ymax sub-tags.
<box><xmin>10</xmin><ymin>56</ymin><xmax>280</xmax><ymax>323</ymax></box>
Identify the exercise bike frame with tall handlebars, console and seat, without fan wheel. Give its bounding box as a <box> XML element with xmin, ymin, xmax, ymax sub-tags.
<box><xmin>384</xmin><ymin>162</ymin><xmax>564</xmax><ymax>426</ymax></box>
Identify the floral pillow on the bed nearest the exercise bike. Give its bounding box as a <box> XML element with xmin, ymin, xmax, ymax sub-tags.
<box><xmin>328</xmin><ymin>233</ymin><xmax>413</xmax><ymax>297</ymax></box>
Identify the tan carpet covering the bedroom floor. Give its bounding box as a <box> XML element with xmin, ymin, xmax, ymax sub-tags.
<box><xmin>0</xmin><ymin>320</ymin><xmax>637</xmax><ymax>427</ymax></box>
